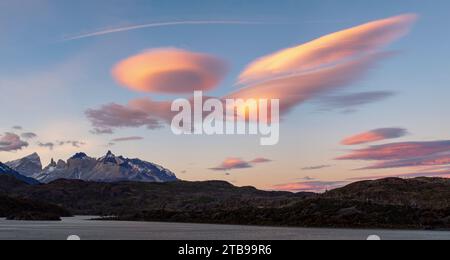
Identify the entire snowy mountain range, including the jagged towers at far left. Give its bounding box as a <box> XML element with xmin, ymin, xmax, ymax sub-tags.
<box><xmin>2</xmin><ymin>151</ymin><xmax>177</xmax><ymax>183</ymax></box>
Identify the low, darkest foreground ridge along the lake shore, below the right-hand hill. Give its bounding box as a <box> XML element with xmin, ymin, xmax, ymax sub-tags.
<box><xmin>110</xmin><ymin>197</ymin><xmax>450</xmax><ymax>229</ymax></box>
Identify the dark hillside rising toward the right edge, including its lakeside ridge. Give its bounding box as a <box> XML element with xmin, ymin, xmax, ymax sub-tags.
<box><xmin>101</xmin><ymin>178</ymin><xmax>450</xmax><ymax>229</ymax></box>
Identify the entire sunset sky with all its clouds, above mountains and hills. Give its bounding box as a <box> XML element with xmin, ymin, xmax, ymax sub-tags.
<box><xmin>0</xmin><ymin>0</ymin><xmax>450</xmax><ymax>191</ymax></box>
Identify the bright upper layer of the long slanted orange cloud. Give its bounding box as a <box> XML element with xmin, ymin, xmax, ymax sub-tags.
<box><xmin>239</xmin><ymin>14</ymin><xmax>417</xmax><ymax>84</ymax></box>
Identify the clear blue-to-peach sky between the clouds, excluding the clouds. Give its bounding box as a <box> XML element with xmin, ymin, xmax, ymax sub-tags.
<box><xmin>0</xmin><ymin>0</ymin><xmax>450</xmax><ymax>189</ymax></box>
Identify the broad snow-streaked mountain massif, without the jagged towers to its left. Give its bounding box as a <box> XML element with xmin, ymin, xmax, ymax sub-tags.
<box><xmin>34</xmin><ymin>151</ymin><xmax>177</xmax><ymax>183</ymax></box>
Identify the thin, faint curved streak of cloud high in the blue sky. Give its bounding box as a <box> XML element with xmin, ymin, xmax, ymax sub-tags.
<box><xmin>63</xmin><ymin>20</ymin><xmax>265</xmax><ymax>41</ymax></box>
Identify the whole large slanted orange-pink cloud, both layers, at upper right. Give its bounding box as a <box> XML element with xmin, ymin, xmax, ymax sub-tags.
<box><xmin>231</xmin><ymin>14</ymin><xmax>417</xmax><ymax>115</ymax></box>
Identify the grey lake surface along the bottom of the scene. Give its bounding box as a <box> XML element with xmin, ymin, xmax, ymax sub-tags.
<box><xmin>0</xmin><ymin>217</ymin><xmax>450</xmax><ymax>240</ymax></box>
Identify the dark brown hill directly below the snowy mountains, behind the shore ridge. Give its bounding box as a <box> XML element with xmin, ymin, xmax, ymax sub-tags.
<box><xmin>10</xmin><ymin>180</ymin><xmax>312</xmax><ymax>215</ymax></box>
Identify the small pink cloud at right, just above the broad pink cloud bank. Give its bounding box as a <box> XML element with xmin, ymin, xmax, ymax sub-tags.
<box><xmin>341</xmin><ymin>128</ymin><xmax>408</xmax><ymax>145</ymax></box>
